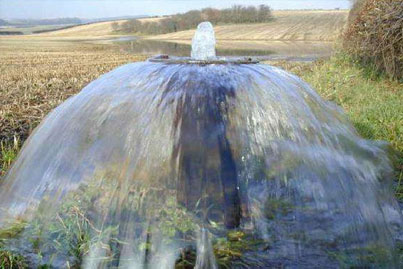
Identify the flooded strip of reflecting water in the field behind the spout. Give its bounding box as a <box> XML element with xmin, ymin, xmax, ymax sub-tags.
<box><xmin>114</xmin><ymin>37</ymin><xmax>332</xmax><ymax>61</ymax></box>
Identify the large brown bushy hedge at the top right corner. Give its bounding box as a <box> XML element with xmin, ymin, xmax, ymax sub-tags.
<box><xmin>343</xmin><ymin>0</ymin><xmax>403</xmax><ymax>79</ymax></box>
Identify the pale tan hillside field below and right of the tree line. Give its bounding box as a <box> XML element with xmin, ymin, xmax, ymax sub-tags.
<box><xmin>147</xmin><ymin>10</ymin><xmax>348</xmax><ymax>41</ymax></box>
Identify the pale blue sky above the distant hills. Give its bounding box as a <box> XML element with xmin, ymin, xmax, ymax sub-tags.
<box><xmin>0</xmin><ymin>0</ymin><xmax>350</xmax><ymax>19</ymax></box>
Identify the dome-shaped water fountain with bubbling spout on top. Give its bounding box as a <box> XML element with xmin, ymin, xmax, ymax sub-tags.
<box><xmin>0</xmin><ymin>23</ymin><xmax>402</xmax><ymax>268</ymax></box>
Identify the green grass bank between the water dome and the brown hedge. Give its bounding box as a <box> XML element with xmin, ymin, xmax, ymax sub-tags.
<box><xmin>274</xmin><ymin>54</ymin><xmax>403</xmax><ymax>199</ymax></box>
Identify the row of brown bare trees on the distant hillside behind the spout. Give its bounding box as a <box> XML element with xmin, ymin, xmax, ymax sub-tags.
<box><xmin>112</xmin><ymin>5</ymin><xmax>273</xmax><ymax>35</ymax></box>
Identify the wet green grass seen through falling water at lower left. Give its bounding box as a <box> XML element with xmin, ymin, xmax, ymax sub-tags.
<box><xmin>0</xmin><ymin>175</ymin><xmax>262</xmax><ymax>269</ymax></box>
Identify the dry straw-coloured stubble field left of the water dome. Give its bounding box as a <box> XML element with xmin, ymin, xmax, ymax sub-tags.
<box><xmin>0</xmin><ymin>38</ymin><xmax>144</xmax><ymax>176</ymax></box>
